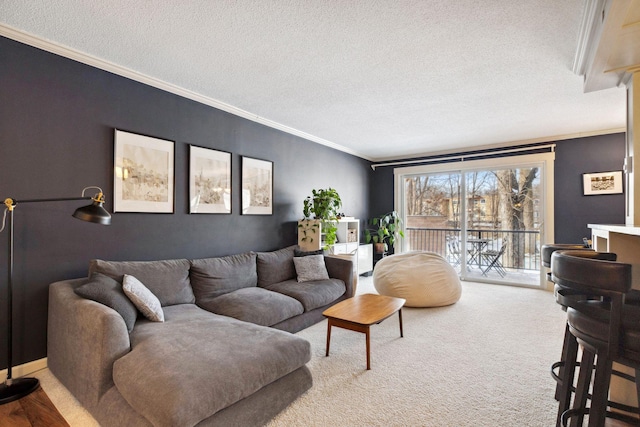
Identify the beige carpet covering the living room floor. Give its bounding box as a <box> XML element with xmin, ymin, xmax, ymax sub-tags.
<box><xmin>38</xmin><ymin>278</ymin><xmax>565</xmax><ymax>427</ymax></box>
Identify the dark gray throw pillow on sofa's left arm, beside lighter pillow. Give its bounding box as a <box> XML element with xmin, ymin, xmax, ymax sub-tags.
<box><xmin>74</xmin><ymin>273</ymin><xmax>138</xmax><ymax>333</ymax></box>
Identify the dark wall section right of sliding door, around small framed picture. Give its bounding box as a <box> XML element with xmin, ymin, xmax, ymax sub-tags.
<box><xmin>554</xmin><ymin>133</ymin><xmax>625</xmax><ymax>243</ymax></box>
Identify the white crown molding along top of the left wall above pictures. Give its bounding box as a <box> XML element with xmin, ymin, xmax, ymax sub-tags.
<box><xmin>0</xmin><ymin>24</ymin><xmax>372</xmax><ymax>161</ymax></box>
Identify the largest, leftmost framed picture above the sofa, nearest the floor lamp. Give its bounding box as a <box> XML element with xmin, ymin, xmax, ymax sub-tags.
<box><xmin>113</xmin><ymin>129</ymin><xmax>175</xmax><ymax>213</ymax></box>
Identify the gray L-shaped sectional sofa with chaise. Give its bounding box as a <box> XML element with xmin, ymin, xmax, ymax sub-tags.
<box><xmin>47</xmin><ymin>246</ymin><xmax>353</xmax><ymax>427</ymax></box>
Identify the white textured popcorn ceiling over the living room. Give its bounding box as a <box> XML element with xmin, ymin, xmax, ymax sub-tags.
<box><xmin>0</xmin><ymin>0</ymin><xmax>626</xmax><ymax>160</ymax></box>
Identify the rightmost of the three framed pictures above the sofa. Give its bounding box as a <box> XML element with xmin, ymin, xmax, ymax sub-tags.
<box><xmin>242</xmin><ymin>156</ymin><xmax>273</xmax><ymax>215</ymax></box>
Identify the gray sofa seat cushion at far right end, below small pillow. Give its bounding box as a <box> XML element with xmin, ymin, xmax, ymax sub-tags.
<box><xmin>267</xmin><ymin>279</ymin><xmax>347</xmax><ymax>311</ymax></box>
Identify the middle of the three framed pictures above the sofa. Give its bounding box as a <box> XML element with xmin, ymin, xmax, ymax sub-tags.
<box><xmin>189</xmin><ymin>145</ymin><xmax>231</xmax><ymax>214</ymax></box>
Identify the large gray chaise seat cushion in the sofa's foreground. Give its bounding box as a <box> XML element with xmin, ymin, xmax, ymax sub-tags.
<box><xmin>113</xmin><ymin>304</ymin><xmax>311</xmax><ymax>427</ymax></box>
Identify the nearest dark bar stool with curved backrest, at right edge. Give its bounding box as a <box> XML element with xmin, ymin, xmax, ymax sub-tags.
<box><xmin>551</xmin><ymin>251</ymin><xmax>640</xmax><ymax>427</ymax></box>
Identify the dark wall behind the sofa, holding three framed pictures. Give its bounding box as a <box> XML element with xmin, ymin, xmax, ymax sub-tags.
<box><xmin>0</xmin><ymin>38</ymin><xmax>372</xmax><ymax>369</ymax></box>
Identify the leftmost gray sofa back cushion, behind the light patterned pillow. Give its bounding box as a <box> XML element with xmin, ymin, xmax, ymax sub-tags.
<box><xmin>89</xmin><ymin>259</ymin><xmax>195</xmax><ymax>307</ymax></box>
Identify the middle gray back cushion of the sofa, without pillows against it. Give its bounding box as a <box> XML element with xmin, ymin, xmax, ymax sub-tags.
<box><xmin>191</xmin><ymin>252</ymin><xmax>258</xmax><ymax>302</ymax></box>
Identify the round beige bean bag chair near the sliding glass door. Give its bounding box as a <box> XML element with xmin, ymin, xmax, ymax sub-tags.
<box><xmin>373</xmin><ymin>252</ymin><xmax>462</xmax><ymax>307</ymax></box>
